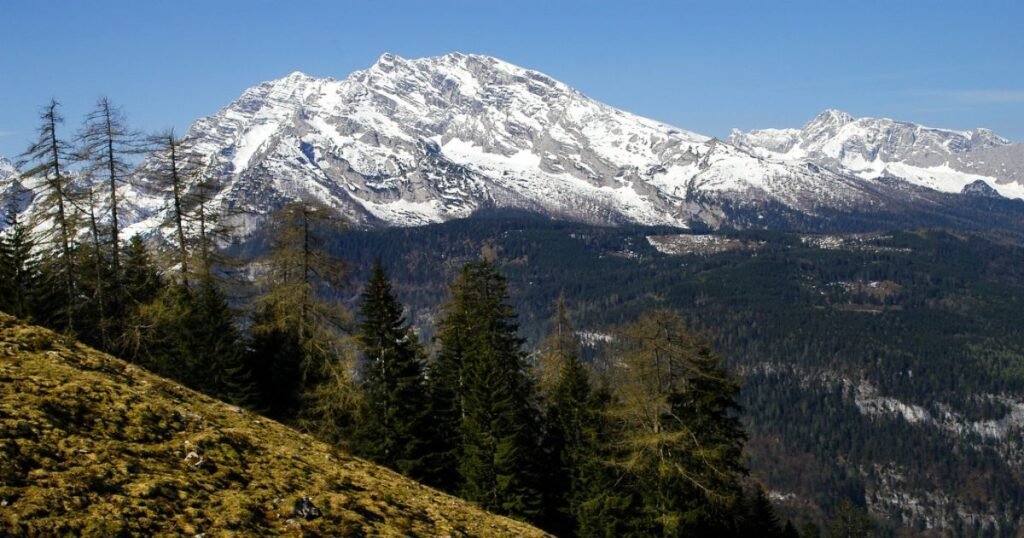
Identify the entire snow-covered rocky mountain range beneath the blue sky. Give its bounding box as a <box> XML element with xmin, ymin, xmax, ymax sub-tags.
<box><xmin>6</xmin><ymin>52</ymin><xmax>1024</xmax><ymax>235</ymax></box>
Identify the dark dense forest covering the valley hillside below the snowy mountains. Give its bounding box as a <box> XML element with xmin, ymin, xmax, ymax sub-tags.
<box><xmin>317</xmin><ymin>215</ymin><xmax>1024</xmax><ymax>533</ymax></box>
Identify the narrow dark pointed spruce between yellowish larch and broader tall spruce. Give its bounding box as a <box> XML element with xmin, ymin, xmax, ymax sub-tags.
<box><xmin>357</xmin><ymin>258</ymin><xmax>427</xmax><ymax>478</ymax></box>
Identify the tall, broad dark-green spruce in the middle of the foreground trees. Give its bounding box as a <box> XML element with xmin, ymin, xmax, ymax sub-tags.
<box><xmin>431</xmin><ymin>261</ymin><xmax>541</xmax><ymax>520</ymax></box>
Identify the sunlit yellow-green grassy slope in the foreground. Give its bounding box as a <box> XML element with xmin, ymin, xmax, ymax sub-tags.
<box><xmin>0</xmin><ymin>314</ymin><xmax>543</xmax><ymax>536</ymax></box>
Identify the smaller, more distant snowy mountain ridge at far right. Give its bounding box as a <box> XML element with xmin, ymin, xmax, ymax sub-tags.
<box><xmin>729</xmin><ymin>110</ymin><xmax>1024</xmax><ymax>198</ymax></box>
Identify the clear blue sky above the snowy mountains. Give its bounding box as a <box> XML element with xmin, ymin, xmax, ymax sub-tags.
<box><xmin>0</xmin><ymin>0</ymin><xmax>1024</xmax><ymax>156</ymax></box>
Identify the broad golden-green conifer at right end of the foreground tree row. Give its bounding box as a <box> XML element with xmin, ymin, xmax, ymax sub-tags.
<box><xmin>611</xmin><ymin>311</ymin><xmax>745</xmax><ymax>536</ymax></box>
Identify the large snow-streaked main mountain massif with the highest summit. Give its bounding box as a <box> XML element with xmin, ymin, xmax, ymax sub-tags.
<box><xmin>119</xmin><ymin>53</ymin><xmax>913</xmax><ymax>235</ymax></box>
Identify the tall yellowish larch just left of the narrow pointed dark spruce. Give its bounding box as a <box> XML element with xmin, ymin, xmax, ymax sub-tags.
<box><xmin>252</xmin><ymin>202</ymin><xmax>359</xmax><ymax>443</ymax></box>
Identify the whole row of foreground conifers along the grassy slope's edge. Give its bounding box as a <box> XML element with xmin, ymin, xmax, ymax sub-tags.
<box><xmin>0</xmin><ymin>99</ymin><xmax>870</xmax><ymax>536</ymax></box>
